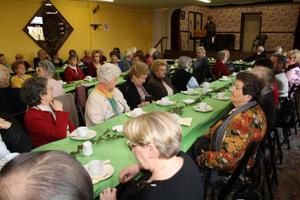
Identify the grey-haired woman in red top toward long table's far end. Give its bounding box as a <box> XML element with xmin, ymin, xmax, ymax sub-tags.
<box><xmin>212</xmin><ymin>50</ymin><xmax>230</xmax><ymax>79</ymax></box>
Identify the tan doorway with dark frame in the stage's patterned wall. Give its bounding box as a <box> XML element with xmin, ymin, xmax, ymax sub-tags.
<box><xmin>240</xmin><ymin>13</ymin><xmax>262</xmax><ymax>52</ymax></box>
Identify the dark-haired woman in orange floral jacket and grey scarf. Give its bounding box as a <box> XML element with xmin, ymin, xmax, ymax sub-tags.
<box><xmin>194</xmin><ymin>72</ymin><xmax>267</xmax><ymax>173</ymax></box>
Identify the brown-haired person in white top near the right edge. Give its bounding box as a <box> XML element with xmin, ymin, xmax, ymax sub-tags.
<box><xmin>271</xmin><ymin>54</ymin><xmax>289</xmax><ymax>98</ymax></box>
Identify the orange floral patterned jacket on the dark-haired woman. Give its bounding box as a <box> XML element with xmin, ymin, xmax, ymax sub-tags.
<box><xmin>200</xmin><ymin>105</ymin><xmax>267</xmax><ymax>172</ymax></box>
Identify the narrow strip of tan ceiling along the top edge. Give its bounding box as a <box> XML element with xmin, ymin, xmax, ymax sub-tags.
<box><xmin>85</xmin><ymin>0</ymin><xmax>300</xmax><ymax>8</ymax></box>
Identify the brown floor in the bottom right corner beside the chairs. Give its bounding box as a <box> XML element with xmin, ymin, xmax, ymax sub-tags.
<box><xmin>274</xmin><ymin>128</ymin><xmax>300</xmax><ymax>200</ymax></box>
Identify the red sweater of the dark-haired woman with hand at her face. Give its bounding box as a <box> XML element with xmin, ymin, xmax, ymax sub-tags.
<box><xmin>24</xmin><ymin>108</ymin><xmax>76</xmax><ymax>147</ymax></box>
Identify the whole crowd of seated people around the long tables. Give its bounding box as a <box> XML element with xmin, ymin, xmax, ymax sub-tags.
<box><xmin>0</xmin><ymin>46</ymin><xmax>300</xmax><ymax>200</ymax></box>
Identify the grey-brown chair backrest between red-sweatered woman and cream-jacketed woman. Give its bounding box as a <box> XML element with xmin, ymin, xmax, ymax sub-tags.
<box><xmin>54</xmin><ymin>93</ymin><xmax>79</xmax><ymax>127</ymax></box>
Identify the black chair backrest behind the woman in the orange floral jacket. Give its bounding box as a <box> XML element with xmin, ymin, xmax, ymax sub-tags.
<box><xmin>218</xmin><ymin>142</ymin><xmax>258</xmax><ymax>200</ymax></box>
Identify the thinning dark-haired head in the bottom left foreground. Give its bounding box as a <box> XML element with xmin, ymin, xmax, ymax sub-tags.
<box><xmin>0</xmin><ymin>151</ymin><xmax>93</xmax><ymax>200</ymax></box>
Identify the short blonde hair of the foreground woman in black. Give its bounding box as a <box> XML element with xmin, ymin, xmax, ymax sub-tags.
<box><xmin>124</xmin><ymin>112</ymin><xmax>182</xmax><ymax>158</ymax></box>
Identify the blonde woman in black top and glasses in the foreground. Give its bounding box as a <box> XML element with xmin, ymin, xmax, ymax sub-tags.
<box><xmin>100</xmin><ymin>112</ymin><xmax>204</xmax><ymax>200</ymax></box>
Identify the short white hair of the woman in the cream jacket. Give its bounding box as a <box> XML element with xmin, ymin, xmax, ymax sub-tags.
<box><xmin>97</xmin><ymin>63</ymin><xmax>121</xmax><ymax>83</ymax></box>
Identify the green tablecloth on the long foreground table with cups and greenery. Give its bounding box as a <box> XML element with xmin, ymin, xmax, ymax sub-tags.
<box><xmin>33</xmin><ymin>77</ymin><xmax>232</xmax><ymax>197</ymax></box>
